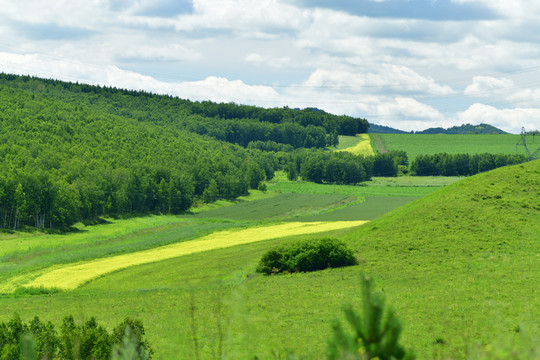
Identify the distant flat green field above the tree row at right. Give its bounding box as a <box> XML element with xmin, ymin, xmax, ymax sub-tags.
<box><xmin>377</xmin><ymin>134</ymin><xmax>526</xmax><ymax>162</ymax></box>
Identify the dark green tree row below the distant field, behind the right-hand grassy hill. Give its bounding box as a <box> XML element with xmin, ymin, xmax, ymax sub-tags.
<box><xmin>411</xmin><ymin>153</ymin><xmax>527</xmax><ymax>176</ymax></box>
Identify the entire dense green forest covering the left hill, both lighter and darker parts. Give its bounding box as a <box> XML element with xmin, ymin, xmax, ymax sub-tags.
<box><xmin>0</xmin><ymin>74</ymin><xmax>380</xmax><ymax>229</ymax></box>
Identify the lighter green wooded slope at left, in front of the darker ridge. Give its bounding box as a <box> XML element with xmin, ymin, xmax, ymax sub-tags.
<box><xmin>0</xmin><ymin>82</ymin><xmax>274</xmax><ymax>228</ymax></box>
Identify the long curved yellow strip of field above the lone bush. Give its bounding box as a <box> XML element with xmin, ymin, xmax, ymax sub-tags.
<box><xmin>20</xmin><ymin>221</ymin><xmax>367</xmax><ymax>290</ymax></box>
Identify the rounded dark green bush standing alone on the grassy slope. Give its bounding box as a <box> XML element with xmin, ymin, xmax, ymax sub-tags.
<box><xmin>257</xmin><ymin>239</ymin><xmax>358</xmax><ymax>275</ymax></box>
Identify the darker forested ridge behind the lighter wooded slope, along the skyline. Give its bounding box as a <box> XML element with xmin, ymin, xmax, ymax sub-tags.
<box><xmin>0</xmin><ymin>74</ymin><xmax>369</xmax><ymax>148</ymax></box>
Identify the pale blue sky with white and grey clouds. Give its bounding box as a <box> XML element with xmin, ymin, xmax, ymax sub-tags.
<box><xmin>0</xmin><ymin>0</ymin><xmax>540</xmax><ymax>133</ymax></box>
